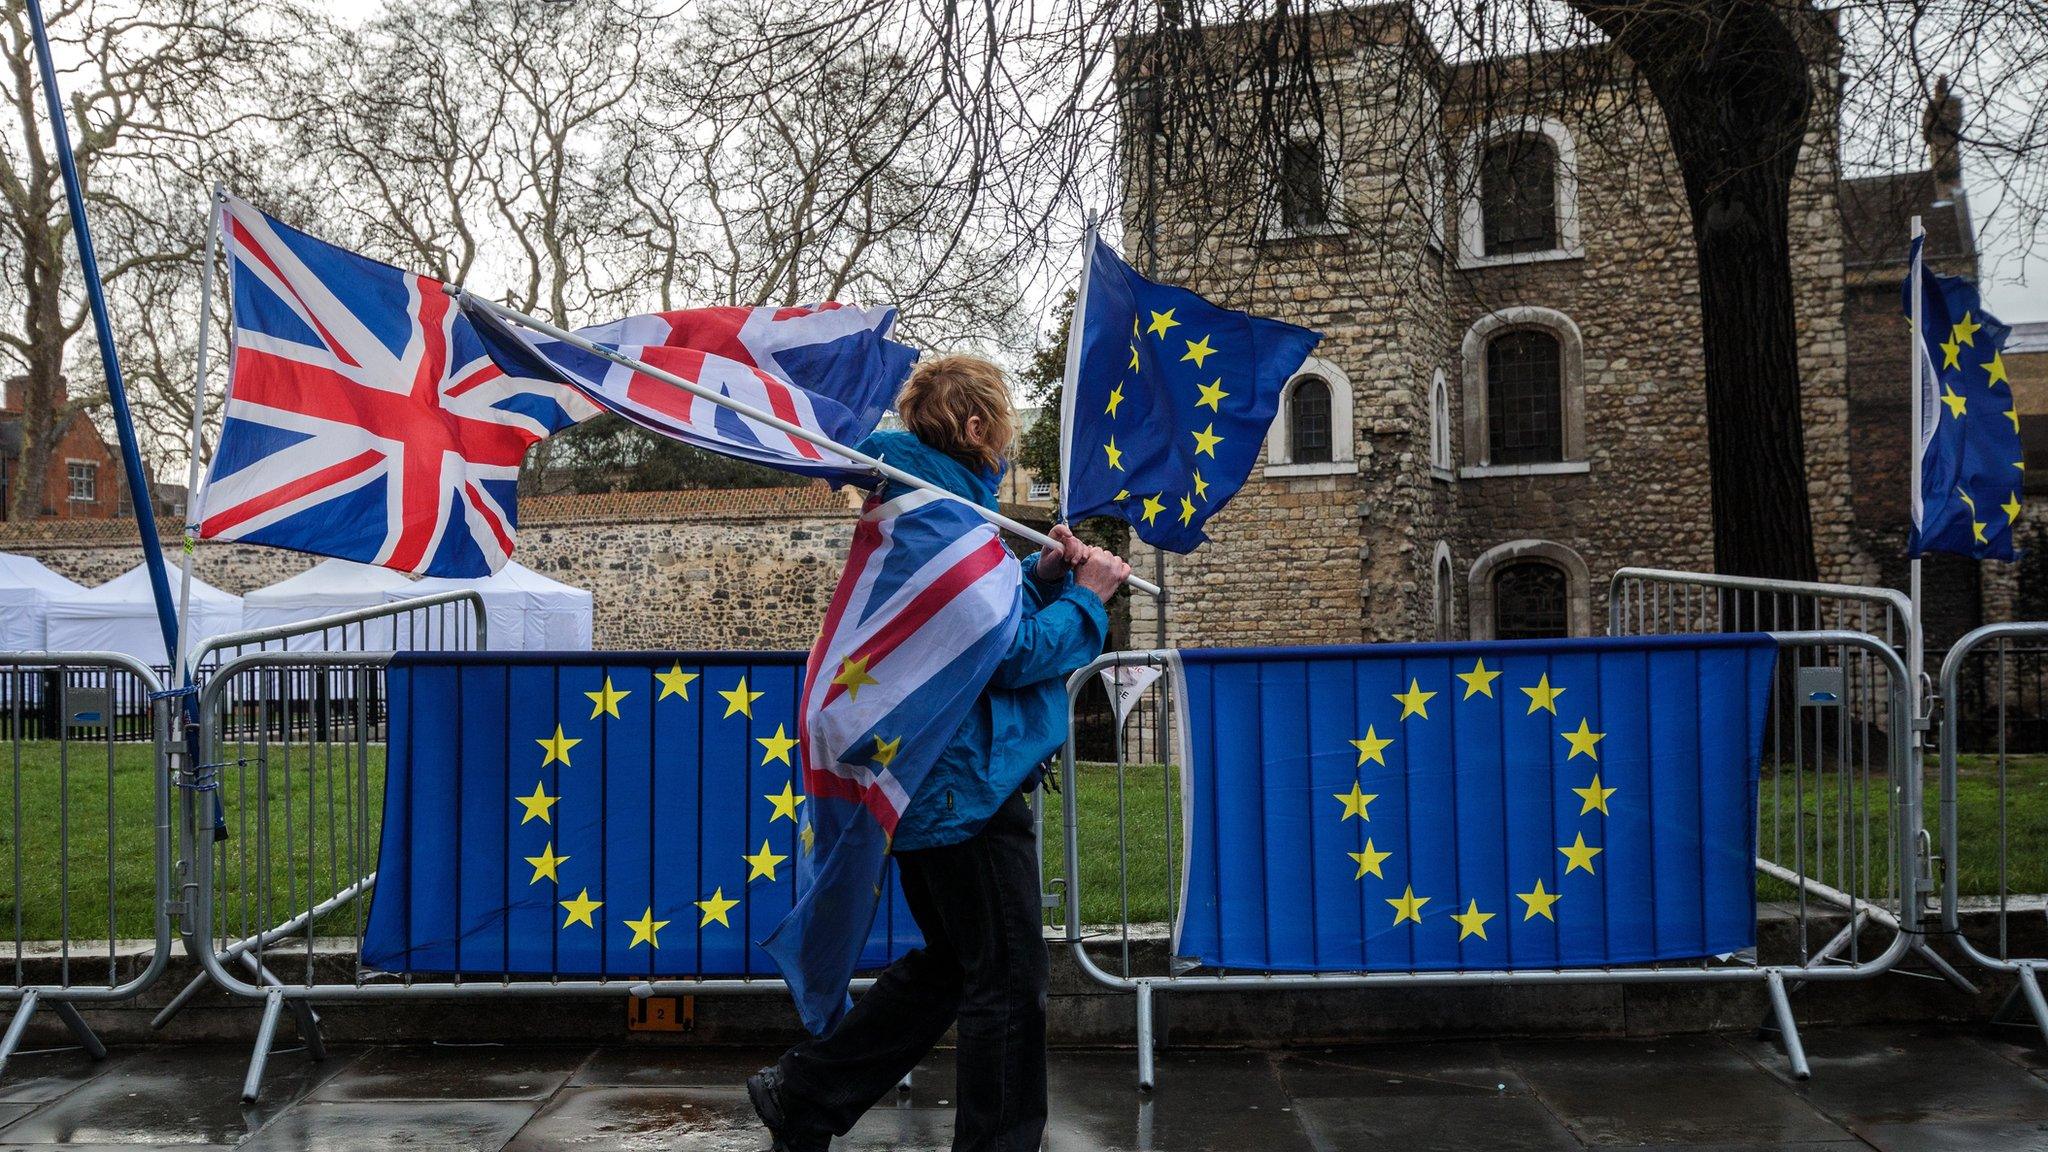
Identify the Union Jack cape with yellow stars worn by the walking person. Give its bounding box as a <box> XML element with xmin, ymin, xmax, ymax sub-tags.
<box><xmin>762</xmin><ymin>492</ymin><xmax>1024</xmax><ymax>1033</ymax></box>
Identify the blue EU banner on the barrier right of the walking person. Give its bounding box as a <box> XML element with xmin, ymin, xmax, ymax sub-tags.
<box><xmin>1176</xmin><ymin>635</ymin><xmax>1776</xmax><ymax>972</ymax></box>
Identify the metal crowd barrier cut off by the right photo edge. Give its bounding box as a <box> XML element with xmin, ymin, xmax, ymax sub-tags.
<box><xmin>1942</xmin><ymin>623</ymin><xmax>2048</xmax><ymax>1039</ymax></box>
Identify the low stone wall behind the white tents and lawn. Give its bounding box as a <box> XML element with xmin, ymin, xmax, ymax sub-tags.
<box><xmin>0</xmin><ymin>486</ymin><xmax>854</xmax><ymax>650</ymax></box>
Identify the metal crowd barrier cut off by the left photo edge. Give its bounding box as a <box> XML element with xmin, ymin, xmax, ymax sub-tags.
<box><xmin>0</xmin><ymin>652</ymin><xmax>170</xmax><ymax>1068</ymax></box>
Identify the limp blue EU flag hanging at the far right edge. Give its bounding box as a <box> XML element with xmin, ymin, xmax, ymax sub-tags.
<box><xmin>1905</xmin><ymin>238</ymin><xmax>2025</xmax><ymax>560</ymax></box>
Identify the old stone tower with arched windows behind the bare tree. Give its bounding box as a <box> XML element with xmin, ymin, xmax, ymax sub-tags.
<box><xmin>1124</xmin><ymin>6</ymin><xmax>1905</xmax><ymax>644</ymax></box>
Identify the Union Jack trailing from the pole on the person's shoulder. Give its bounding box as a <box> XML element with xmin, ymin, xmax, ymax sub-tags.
<box><xmin>463</xmin><ymin>297</ymin><xmax>918</xmax><ymax>480</ymax></box>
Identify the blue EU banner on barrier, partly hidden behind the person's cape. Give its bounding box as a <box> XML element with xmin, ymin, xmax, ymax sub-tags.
<box><xmin>362</xmin><ymin>652</ymin><xmax>920</xmax><ymax>978</ymax></box>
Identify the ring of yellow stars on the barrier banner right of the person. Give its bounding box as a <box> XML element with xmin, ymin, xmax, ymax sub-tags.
<box><xmin>1331</xmin><ymin>656</ymin><xmax>1620</xmax><ymax>941</ymax></box>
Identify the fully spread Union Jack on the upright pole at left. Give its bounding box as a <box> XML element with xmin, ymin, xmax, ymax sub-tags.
<box><xmin>199</xmin><ymin>199</ymin><xmax>598</xmax><ymax>576</ymax></box>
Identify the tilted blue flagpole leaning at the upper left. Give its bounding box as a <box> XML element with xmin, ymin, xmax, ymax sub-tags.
<box><xmin>29</xmin><ymin>0</ymin><xmax>182</xmax><ymax>664</ymax></box>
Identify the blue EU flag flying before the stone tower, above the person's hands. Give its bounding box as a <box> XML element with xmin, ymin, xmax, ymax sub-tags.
<box><xmin>1059</xmin><ymin>232</ymin><xmax>1318</xmax><ymax>551</ymax></box>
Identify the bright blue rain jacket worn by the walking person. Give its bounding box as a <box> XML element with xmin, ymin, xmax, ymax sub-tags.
<box><xmin>860</xmin><ymin>433</ymin><xmax>1110</xmax><ymax>853</ymax></box>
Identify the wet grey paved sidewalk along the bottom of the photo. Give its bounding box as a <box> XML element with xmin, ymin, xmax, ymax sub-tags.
<box><xmin>0</xmin><ymin>1027</ymin><xmax>2048</xmax><ymax>1152</ymax></box>
